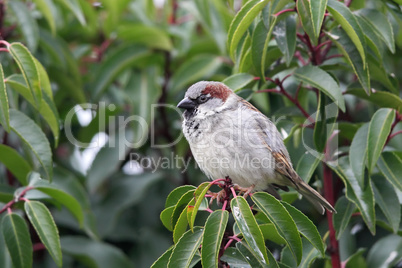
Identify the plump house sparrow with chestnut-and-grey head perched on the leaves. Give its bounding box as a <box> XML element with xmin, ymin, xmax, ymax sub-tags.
<box><xmin>177</xmin><ymin>81</ymin><xmax>336</xmax><ymax>214</ymax></box>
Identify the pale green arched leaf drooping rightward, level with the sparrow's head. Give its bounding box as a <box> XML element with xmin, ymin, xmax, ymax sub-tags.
<box><xmin>294</xmin><ymin>65</ymin><xmax>345</xmax><ymax>112</ymax></box>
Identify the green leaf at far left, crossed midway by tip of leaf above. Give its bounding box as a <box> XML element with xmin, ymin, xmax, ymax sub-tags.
<box><xmin>6</xmin><ymin>75</ymin><xmax>60</xmax><ymax>147</ymax></box>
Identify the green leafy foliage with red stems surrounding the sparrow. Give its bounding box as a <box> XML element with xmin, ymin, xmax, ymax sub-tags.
<box><xmin>0</xmin><ymin>0</ymin><xmax>402</xmax><ymax>267</ymax></box>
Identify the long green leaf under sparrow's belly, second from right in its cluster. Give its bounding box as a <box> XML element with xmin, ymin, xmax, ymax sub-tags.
<box><xmin>251</xmin><ymin>192</ymin><xmax>302</xmax><ymax>263</ymax></box>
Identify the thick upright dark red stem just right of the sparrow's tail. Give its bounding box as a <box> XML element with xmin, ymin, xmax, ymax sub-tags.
<box><xmin>323</xmin><ymin>163</ymin><xmax>341</xmax><ymax>268</ymax></box>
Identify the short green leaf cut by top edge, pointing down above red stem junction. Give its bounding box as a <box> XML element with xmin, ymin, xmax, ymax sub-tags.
<box><xmin>296</xmin><ymin>0</ymin><xmax>316</xmax><ymax>45</ymax></box>
